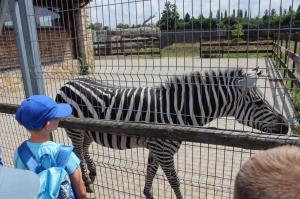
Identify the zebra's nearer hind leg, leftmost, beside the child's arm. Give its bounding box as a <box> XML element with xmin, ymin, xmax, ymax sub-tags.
<box><xmin>66</xmin><ymin>129</ymin><xmax>94</xmax><ymax>193</ymax></box>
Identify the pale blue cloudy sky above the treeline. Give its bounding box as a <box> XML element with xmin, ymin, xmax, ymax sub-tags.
<box><xmin>88</xmin><ymin>0</ymin><xmax>300</xmax><ymax>27</ymax></box>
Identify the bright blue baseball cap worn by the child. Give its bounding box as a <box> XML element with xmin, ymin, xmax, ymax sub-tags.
<box><xmin>16</xmin><ymin>95</ymin><xmax>72</xmax><ymax>130</ymax></box>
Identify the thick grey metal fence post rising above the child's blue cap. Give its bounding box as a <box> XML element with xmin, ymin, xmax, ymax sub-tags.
<box><xmin>9</xmin><ymin>0</ymin><xmax>45</xmax><ymax>97</ymax></box>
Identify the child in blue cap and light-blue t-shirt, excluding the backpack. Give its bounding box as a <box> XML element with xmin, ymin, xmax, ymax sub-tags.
<box><xmin>14</xmin><ymin>95</ymin><xmax>86</xmax><ymax>199</ymax></box>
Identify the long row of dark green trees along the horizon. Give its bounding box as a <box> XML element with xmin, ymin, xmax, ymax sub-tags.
<box><xmin>157</xmin><ymin>1</ymin><xmax>300</xmax><ymax>30</ymax></box>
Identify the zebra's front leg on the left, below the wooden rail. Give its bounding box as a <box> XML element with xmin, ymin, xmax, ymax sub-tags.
<box><xmin>144</xmin><ymin>152</ymin><xmax>158</xmax><ymax>199</ymax></box>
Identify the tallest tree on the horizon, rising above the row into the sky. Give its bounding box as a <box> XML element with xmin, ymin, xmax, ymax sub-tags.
<box><xmin>158</xmin><ymin>1</ymin><xmax>179</xmax><ymax>30</ymax></box>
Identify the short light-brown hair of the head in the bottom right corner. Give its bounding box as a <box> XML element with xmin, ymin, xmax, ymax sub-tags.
<box><xmin>234</xmin><ymin>146</ymin><xmax>300</xmax><ymax>199</ymax></box>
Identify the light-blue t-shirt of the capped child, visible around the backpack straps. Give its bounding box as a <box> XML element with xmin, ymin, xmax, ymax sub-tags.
<box><xmin>14</xmin><ymin>141</ymin><xmax>80</xmax><ymax>175</ymax></box>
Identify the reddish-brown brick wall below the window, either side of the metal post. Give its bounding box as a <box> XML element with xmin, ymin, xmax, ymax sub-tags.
<box><xmin>0</xmin><ymin>29</ymin><xmax>73</xmax><ymax>69</ymax></box>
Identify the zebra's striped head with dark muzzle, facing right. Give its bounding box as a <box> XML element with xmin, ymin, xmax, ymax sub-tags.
<box><xmin>234</xmin><ymin>70</ymin><xmax>289</xmax><ymax>134</ymax></box>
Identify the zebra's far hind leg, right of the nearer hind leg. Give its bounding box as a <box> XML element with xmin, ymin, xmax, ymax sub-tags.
<box><xmin>83</xmin><ymin>135</ymin><xmax>97</xmax><ymax>183</ymax></box>
